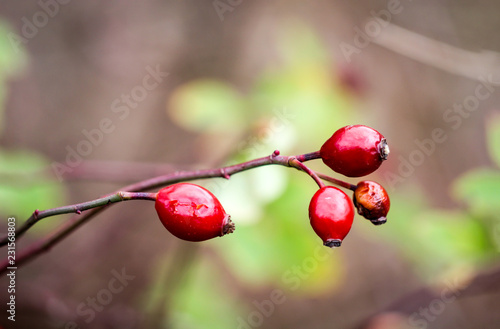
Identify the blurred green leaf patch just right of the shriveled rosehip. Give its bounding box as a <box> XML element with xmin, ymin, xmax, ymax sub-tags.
<box><xmin>372</xmin><ymin>187</ymin><xmax>495</xmax><ymax>281</ymax></box>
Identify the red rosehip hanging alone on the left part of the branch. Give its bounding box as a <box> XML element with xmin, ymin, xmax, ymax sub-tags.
<box><xmin>155</xmin><ymin>183</ymin><xmax>234</xmax><ymax>241</ymax></box>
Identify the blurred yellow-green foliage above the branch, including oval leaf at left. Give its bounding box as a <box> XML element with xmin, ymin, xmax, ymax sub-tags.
<box><xmin>167</xmin><ymin>24</ymin><xmax>352</xmax><ymax>157</ymax></box>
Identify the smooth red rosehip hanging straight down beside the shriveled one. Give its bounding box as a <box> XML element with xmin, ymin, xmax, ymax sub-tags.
<box><xmin>309</xmin><ymin>186</ymin><xmax>354</xmax><ymax>247</ymax></box>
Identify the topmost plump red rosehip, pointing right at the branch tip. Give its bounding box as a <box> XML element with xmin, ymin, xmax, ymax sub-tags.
<box><xmin>320</xmin><ymin>125</ymin><xmax>389</xmax><ymax>177</ymax></box>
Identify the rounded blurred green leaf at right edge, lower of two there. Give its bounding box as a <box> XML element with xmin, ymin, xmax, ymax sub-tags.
<box><xmin>452</xmin><ymin>168</ymin><xmax>500</xmax><ymax>215</ymax></box>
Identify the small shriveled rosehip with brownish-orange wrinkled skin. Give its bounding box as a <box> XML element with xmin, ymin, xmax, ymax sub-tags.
<box><xmin>352</xmin><ymin>180</ymin><xmax>391</xmax><ymax>225</ymax></box>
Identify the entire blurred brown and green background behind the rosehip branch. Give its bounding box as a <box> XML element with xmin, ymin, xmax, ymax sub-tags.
<box><xmin>0</xmin><ymin>0</ymin><xmax>500</xmax><ymax>329</ymax></box>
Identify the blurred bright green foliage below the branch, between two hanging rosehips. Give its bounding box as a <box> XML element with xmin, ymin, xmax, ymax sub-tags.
<box><xmin>214</xmin><ymin>179</ymin><xmax>341</xmax><ymax>295</ymax></box>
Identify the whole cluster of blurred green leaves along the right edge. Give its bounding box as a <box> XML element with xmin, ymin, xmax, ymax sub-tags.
<box><xmin>377</xmin><ymin>115</ymin><xmax>500</xmax><ymax>282</ymax></box>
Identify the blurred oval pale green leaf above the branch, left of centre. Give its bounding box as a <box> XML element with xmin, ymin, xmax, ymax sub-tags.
<box><xmin>168</xmin><ymin>79</ymin><xmax>246</xmax><ymax>133</ymax></box>
